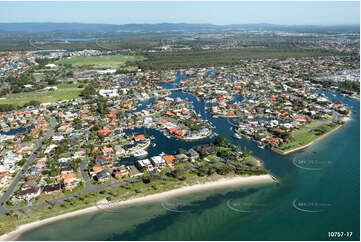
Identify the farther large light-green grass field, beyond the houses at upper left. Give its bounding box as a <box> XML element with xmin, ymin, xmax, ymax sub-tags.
<box><xmin>55</xmin><ymin>55</ymin><xmax>145</xmax><ymax>68</ymax></box>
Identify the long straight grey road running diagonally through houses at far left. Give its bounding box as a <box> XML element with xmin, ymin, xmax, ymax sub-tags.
<box><xmin>0</xmin><ymin>116</ymin><xmax>56</xmax><ymax>216</ymax></box>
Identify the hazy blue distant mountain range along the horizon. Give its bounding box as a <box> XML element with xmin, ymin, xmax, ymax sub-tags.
<box><xmin>0</xmin><ymin>23</ymin><xmax>360</xmax><ymax>33</ymax></box>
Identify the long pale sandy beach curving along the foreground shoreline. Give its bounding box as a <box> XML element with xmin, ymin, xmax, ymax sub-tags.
<box><xmin>0</xmin><ymin>175</ymin><xmax>274</xmax><ymax>241</ymax></box>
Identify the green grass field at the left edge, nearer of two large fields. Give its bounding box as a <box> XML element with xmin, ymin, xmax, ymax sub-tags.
<box><xmin>0</xmin><ymin>86</ymin><xmax>83</xmax><ymax>106</ymax></box>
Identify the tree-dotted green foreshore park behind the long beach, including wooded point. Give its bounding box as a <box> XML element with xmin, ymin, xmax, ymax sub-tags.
<box><xmin>0</xmin><ymin>138</ymin><xmax>267</xmax><ymax>234</ymax></box>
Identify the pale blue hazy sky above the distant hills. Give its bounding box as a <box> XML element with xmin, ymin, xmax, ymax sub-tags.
<box><xmin>0</xmin><ymin>1</ymin><xmax>360</xmax><ymax>25</ymax></box>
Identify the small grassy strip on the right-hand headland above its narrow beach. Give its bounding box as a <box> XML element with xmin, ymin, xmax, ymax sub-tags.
<box><xmin>277</xmin><ymin>123</ymin><xmax>340</xmax><ymax>152</ymax></box>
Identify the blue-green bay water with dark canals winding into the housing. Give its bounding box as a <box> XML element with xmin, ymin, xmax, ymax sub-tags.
<box><xmin>19</xmin><ymin>81</ymin><xmax>360</xmax><ymax>240</ymax></box>
